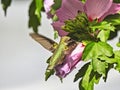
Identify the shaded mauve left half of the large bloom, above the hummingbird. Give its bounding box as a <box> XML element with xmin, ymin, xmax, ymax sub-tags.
<box><xmin>52</xmin><ymin>0</ymin><xmax>84</xmax><ymax>37</ymax></box>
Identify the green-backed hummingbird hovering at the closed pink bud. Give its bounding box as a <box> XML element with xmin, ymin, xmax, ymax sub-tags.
<box><xmin>30</xmin><ymin>33</ymin><xmax>78</xmax><ymax>80</ymax></box>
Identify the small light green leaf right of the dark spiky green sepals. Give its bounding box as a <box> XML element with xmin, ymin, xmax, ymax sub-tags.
<box><xmin>97</xmin><ymin>30</ymin><xmax>110</xmax><ymax>42</ymax></box>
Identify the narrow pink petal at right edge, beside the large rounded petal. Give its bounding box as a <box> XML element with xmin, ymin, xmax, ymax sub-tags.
<box><xmin>99</xmin><ymin>3</ymin><xmax>120</xmax><ymax>21</ymax></box>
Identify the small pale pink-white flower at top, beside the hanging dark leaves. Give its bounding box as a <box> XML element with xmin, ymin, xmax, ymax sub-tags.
<box><xmin>44</xmin><ymin>0</ymin><xmax>54</xmax><ymax>18</ymax></box>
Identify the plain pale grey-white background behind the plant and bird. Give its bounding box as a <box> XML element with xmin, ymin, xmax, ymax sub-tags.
<box><xmin>0</xmin><ymin>0</ymin><xmax>120</xmax><ymax>90</ymax></box>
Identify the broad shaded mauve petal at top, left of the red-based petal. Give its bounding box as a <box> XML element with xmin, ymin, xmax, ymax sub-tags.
<box><xmin>56</xmin><ymin>0</ymin><xmax>84</xmax><ymax>22</ymax></box>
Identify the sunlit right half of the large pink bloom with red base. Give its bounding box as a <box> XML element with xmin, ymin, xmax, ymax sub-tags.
<box><xmin>84</xmin><ymin>0</ymin><xmax>120</xmax><ymax>21</ymax></box>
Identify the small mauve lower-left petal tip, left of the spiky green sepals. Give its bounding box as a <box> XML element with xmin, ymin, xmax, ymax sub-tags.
<box><xmin>52</xmin><ymin>21</ymin><xmax>68</xmax><ymax>37</ymax></box>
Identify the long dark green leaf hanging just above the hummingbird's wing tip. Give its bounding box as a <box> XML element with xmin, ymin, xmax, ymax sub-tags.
<box><xmin>29</xmin><ymin>0</ymin><xmax>40</xmax><ymax>33</ymax></box>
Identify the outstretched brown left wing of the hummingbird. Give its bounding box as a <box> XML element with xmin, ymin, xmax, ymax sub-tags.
<box><xmin>30</xmin><ymin>33</ymin><xmax>58</xmax><ymax>53</ymax></box>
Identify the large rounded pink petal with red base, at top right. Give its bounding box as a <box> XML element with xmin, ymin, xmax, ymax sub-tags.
<box><xmin>84</xmin><ymin>0</ymin><xmax>113</xmax><ymax>20</ymax></box>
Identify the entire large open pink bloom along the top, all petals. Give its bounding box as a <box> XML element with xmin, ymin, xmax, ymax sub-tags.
<box><xmin>52</xmin><ymin>0</ymin><xmax>120</xmax><ymax>36</ymax></box>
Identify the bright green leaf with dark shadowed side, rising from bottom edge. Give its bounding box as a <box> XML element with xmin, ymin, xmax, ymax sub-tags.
<box><xmin>79</xmin><ymin>64</ymin><xmax>102</xmax><ymax>90</ymax></box>
